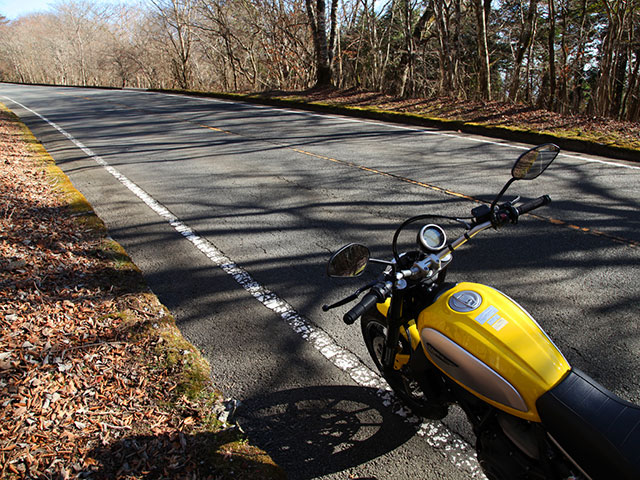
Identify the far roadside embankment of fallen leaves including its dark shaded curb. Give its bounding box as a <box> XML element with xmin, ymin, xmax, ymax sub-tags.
<box><xmin>149</xmin><ymin>89</ymin><xmax>640</xmax><ymax>162</ymax></box>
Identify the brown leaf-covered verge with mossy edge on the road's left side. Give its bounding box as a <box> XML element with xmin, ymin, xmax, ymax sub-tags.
<box><xmin>0</xmin><ymin>104</ymin><xmax>284</xmax><ymax>480</ymax></box>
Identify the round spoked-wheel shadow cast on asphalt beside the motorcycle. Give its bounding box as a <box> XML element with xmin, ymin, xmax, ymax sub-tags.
<box><xmin>236</xmin><ymin>386</ymin><xmax>416</xmax><ymax>480</ymax></box>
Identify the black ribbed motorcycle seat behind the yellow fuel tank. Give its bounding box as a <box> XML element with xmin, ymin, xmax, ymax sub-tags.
<box><xmin>536</xmin><ymin>369</ymin><xmax>640</xmax><ymax>480</ymax></box>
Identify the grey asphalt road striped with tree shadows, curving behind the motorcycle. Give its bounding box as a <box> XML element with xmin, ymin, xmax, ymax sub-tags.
<box><xmin>0</xmin><ymin>84</ymin><xmax>640</xmax><ymax>479</ymax></box>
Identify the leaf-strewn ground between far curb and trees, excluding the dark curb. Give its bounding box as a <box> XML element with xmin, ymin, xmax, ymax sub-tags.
<box><xmin>259</xmin><ymin>89</ymin><xmax>640</xmax><ymax>151</ymax></box>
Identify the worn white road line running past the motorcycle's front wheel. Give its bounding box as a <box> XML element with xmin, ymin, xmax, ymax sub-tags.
<box><xmin>3</xmin><ymin>96</ymin><xmax>485</xmax><ymax>479</ymax></box>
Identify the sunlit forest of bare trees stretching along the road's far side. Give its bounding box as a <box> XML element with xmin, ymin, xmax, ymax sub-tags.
<box><xmin>0</xmin><ymin>0</ymin><xmax>640</xmax><ymax>121</ymax></box>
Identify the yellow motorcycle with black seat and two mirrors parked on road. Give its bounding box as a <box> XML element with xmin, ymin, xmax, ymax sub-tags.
<box><xmin>323</xmin><ymin>144</ymin><xmax>640</xmax><ymax>480</ymax></box>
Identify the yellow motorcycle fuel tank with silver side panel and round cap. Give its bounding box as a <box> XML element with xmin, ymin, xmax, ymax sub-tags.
<box><xmin>417</xmin><ymin>282</ymin><xmax>570</xmax><ymax>422</ymax></box>
